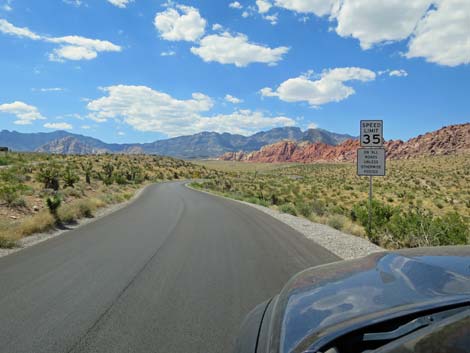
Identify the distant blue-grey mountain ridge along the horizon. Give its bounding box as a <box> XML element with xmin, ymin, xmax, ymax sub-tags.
<box><xmin>0</xmin><ymin>127</ymin><xmax>353</xmax><ymax>159</ymax></box>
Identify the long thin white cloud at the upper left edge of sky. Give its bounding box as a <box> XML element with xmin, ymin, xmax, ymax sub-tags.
<box><xmin>0</xmin><ymin>19</ymin><xmax>121</xmax><ymax>61</ymax></box>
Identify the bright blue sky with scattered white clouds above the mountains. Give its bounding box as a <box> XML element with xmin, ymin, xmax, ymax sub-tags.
<box><xmin>0</xmin><ymin>0</ymin><xmax>470</xmax><ymax>142</ymax></box>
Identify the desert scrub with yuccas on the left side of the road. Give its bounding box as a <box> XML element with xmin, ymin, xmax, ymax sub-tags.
<box><xmin>0</xmin><ymin>153</ymin><xmax>220</xmax><ymax>248</ymax></box>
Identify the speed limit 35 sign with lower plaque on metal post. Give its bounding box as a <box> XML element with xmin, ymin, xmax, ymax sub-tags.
<box><xmin>357</xmin><ymin>120</ymin><xmax>385</xmax><ymax>236</ymax></box>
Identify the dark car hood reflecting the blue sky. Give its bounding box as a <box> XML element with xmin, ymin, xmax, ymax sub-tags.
<box><xmin>270</xmin><ymin>247</ymin><xmax>470</xmax><ymax>353</ymax></box>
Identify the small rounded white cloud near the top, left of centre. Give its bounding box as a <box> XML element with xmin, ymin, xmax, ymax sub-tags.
<box><xmin>154</xmin><ymin>5</ymin><xmax>207</xmax><ymax>42</ymax></box>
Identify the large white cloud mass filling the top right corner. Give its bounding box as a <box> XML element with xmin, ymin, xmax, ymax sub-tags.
<box><xmin>261</xmin><ymin>0</ymin><xmax>470</xmax><ymax>66</ymax></box>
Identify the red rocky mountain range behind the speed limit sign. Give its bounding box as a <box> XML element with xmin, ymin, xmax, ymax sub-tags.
<box><xmin>219</xmin><ymin>123</ymin><xmax>470</xmax><ymax>163</ymax></box>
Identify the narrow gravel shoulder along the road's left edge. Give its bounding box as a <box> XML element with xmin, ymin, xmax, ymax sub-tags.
<box><xmin>0</xmin><ymin>184</ymin><xmax>152</xmax><ymax>257</ymax></box>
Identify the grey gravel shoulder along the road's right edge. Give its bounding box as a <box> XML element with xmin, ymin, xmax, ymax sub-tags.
<box><xmin>186</xmin><ymin>184</ymin><xmax>386</xmax><ymax>260</ymax></box>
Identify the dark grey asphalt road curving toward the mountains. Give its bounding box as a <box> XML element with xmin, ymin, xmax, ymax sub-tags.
<box><xmin>0</xmin><ymin>183</ymin><xmax>337</xmax><ymax>353</ymax></box>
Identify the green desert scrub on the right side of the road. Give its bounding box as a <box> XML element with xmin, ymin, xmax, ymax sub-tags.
<box><xmin>193</xmin><ymin>155</ymin><xmax>470</xmax><ymax>249</ymax></box>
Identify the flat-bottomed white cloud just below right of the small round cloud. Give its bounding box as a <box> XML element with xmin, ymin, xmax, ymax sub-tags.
<box><xmin>191</xmin><ymin>32</ymin><xmax>289</xmax><ymax>67</ymax></box>
